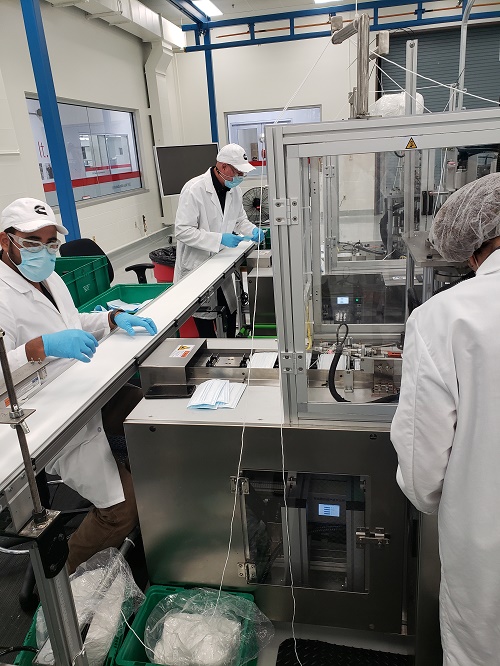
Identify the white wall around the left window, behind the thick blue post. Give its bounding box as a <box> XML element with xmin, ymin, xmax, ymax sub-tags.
<box><xmin>0</xmin><ymin>0</ymin><xmax>166</xmax><ymax>250</ymax></box>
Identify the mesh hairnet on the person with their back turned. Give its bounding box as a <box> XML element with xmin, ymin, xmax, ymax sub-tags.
<box><xmin>429</xmin><ymin>173</ymin><xmax>500</xmax><ymax>261</ymax></box>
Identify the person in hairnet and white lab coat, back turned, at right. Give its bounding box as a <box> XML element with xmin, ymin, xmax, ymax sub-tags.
<box><xmin>391</xmin><ymin>173</ymin><xmax>500</xmax><ymax>666</ymax></box>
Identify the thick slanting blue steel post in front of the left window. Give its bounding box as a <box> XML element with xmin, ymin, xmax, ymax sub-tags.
<box><xmin>21</xmin><ymin>0</ymin><xmax>80</xmax><ymax>240</ymax></box>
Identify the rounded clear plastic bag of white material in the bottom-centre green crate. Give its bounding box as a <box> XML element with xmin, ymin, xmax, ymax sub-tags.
<box><xmin>144</xmin><ymin>588</ymin><xmax>274</xmax><ymax>666</ymax></box>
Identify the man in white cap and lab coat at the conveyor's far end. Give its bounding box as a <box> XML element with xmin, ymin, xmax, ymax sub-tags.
<box><xmin>174</xmin><ymin>143</ymin><xmax>264</xmax><ymax>338</ymax></box>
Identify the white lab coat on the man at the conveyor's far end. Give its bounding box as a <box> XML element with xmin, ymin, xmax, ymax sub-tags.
<box><xmin>174</xmin><ymin>169</ymin><xmax>255</xmax><ymax>319</ymax></box>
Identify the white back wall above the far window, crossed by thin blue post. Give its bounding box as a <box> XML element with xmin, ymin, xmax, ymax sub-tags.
<box><xmin>175</xmin><ymin>38</ymin><xmax>364</xmax><ymax>144</ymax></box>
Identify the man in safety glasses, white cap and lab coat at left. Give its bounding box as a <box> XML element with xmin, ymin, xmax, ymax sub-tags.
<box><xmin>0</xmin><ymin>198</ymin><xmax>156</xmax><ymax>573</ymax></box>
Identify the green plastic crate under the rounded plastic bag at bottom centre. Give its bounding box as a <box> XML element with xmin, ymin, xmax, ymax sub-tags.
<box><xmin>115</xmin><ymin>585</ymin><xmax>257</xmax><ymax>666</ymax></box>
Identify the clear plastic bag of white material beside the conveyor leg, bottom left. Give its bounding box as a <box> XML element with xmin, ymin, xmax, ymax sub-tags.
<box><xmin>36</xmin><ymin>548</ymin><xmax>144</xmax><ymax>666</ymax></box>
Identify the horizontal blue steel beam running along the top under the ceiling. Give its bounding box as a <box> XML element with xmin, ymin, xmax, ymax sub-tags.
<box><xmin>182</xmin><ymin>0</ymin><xmax>500</xmax><ymax>52</ymax></box>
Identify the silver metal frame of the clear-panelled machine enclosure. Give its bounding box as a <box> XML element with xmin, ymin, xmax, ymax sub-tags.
<box><xmin>266</xmin><ymin>109</ymin><xmax>500</xmax><ymax>423</ymax></box>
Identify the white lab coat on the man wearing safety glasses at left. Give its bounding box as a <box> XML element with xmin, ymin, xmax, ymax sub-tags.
<box><xmin>0</xmin><ymin>261</ymin><xmax>125</xmax><ymax>508</ymax></box>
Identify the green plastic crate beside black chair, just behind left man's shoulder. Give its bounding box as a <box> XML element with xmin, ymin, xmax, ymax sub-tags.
<box><xmin>56</xmin><ymin>256</ymin><xmax>109</xmax><ymax>308</ymax></box>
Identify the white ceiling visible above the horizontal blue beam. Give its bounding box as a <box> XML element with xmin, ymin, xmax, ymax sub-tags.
<box><xmin>146</xmin><ymin>0</ymin><xmax>334</xmax><ymax>26</ymax></box>
